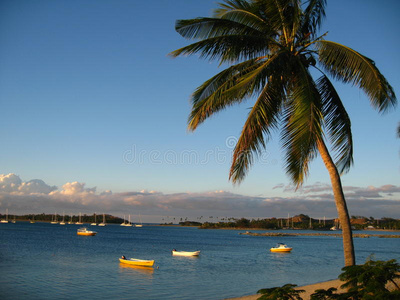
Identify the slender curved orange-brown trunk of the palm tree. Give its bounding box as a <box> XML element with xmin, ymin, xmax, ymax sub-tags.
<box><xmin>318</xmin><ymin>140</ymin><xmax>356</xmax><ymax>266</ymax></box>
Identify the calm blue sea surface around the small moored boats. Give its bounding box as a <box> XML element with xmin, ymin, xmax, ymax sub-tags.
<box><xmin>0</xmin><ymin>222</ymin><xmax>400</xmax><ymax>300</ymax></box>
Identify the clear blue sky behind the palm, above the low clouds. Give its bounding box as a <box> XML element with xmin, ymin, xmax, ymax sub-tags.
<box><xmin>0</xmin><ymin>0</ymin><xmax>400</xmax><ymax>217</ymax></box>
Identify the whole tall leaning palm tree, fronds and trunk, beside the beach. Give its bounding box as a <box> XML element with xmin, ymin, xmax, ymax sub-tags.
<box><xmin>170</xmin><ymin>0</ymin><xmax>397</xmax><ymax>266</ymax></box>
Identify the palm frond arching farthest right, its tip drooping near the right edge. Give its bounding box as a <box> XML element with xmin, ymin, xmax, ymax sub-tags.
<box><xmin>315</xmin><ymin>41</ymin><xmax>397</xmax><ymax>112</ymax></box>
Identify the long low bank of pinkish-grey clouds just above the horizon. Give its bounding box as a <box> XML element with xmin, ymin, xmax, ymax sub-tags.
<box><xmin>0</xmin><ymin>173</ymin><xmax>400</xmax><ymax>222</ymax></box>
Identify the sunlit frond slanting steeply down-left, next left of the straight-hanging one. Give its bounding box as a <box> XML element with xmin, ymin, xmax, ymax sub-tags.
<box><xmin>229</xmin><ymin>75</ymin><xmax>285</xmax><ymax>183</ymax></box>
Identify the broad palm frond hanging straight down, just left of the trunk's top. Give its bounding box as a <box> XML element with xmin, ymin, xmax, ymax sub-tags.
<box><xmin>282</xmin><ymin>57</ymin><xmax>323</xmax><ymax>187</ymax></box>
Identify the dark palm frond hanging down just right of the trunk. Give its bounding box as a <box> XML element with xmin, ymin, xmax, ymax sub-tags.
<box><xmin>317</xmin><ymin>75</ymin><xmax>353</xmax><ymax>173</ymax></box>
